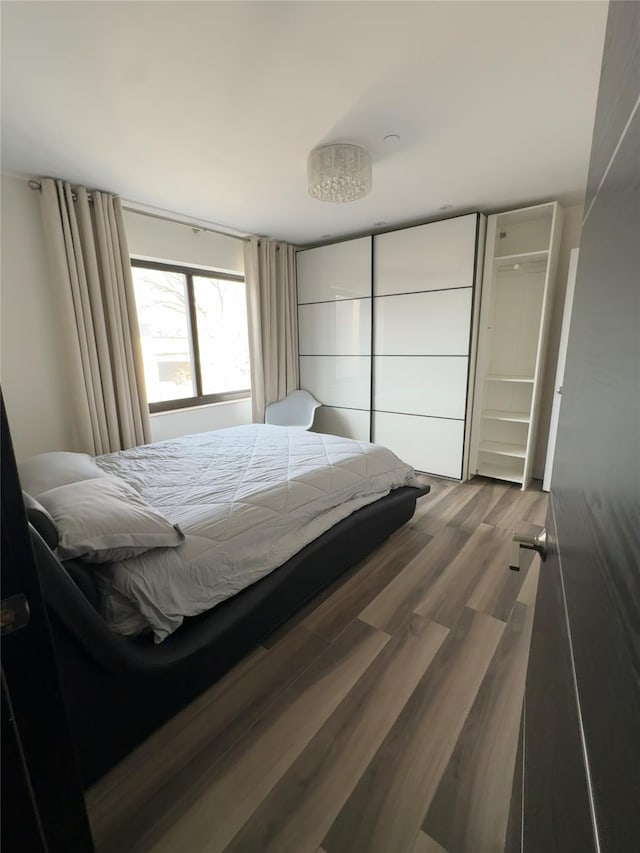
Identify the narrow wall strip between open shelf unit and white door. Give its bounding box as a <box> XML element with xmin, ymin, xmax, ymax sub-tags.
<box><xmin>533</xmin><ymin>204</ymin><xmax>584</xmax><ymax>480</ymax></box>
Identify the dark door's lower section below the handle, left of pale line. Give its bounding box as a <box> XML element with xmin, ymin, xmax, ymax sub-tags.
<box><xmin>523</xmin><ymin>502</ymin><xmax>595</xmax><ymax>853</ymax></box>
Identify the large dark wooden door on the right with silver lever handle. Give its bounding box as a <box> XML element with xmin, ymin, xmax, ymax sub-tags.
<box><xmin>510</xmin><ymin>2</ymin><xmax>640</xmax><ymax>853</ymax></box>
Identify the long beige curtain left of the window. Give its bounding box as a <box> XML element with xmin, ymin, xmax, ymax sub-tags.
<box><xmin>41</xmin><ymin>178</ymin><xmax>151</xmax><ymax>455</ymax></box>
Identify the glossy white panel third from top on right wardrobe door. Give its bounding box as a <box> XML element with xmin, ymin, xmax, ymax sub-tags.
<box><xmin>373</xmin><ymin>356</ymin><xmax>469</xmax><ymax>420</ymax></box>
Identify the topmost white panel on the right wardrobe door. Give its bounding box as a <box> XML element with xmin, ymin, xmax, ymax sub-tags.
<box><xmin>374</xmin><ymin>213</ymin><xmax>478</xmax><ymax>296</ymax></box>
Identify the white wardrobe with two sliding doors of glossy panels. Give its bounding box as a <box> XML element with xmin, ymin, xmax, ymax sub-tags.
<box><xmin>298</xmin><ymin>214</ymin><xmax>485</xmax><ymax>479</ymax></box>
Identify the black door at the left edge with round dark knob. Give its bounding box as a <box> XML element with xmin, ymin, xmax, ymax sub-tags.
<box><xmin>1</xmin><ymin>394</ymin><xmax>93</xmax><ymax>853</ymax></box>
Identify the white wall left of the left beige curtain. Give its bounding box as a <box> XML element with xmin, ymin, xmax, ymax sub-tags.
<box><xmin>0</xmin><ymin>175</ymin><xmax>77</xmax><ymax>459</ymax></box>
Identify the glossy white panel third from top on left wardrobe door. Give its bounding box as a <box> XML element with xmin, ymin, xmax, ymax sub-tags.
<box><xmin>300</xmin><ymin>355</ymin><xmax>371</xmax><ymax>410</ymax></box>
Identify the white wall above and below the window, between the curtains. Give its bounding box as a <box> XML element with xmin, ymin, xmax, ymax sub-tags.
<box><xmin>124</xmin><ymin>210</ymin><xmax>251</xmax><ymax>441</ymax></box>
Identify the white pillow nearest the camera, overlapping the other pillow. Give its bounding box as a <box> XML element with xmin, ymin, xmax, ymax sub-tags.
<box><xmin>38</xmin><ymin>474</ymin><xmax>184</xmax><ymax>563</ymax></box>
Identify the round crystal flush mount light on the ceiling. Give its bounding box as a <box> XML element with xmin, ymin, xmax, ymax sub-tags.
<box><xmin>307</xmin><ymin>144</ymin><xmax>371</xmax><ymax>204</ymax></box>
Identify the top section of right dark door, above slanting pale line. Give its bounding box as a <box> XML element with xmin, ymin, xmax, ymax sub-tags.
<box><xmin>585</xmin><ymin>0</ymin><xmax>640</xmax><ymax>211</ymax></box>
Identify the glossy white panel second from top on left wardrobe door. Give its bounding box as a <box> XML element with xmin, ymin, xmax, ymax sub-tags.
<box><xmin>298</xmin><ymin>299</ymin><xmax>371</xmax><ymax>355</ymax></box>
